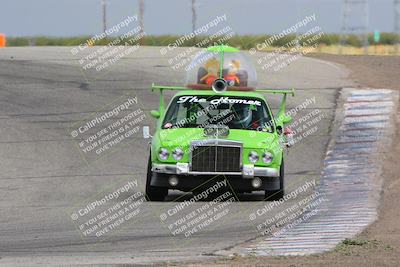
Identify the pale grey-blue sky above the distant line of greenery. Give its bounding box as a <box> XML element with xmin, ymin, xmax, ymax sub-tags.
<box><xmin>0</xmin><ymin>0</ymin><xmax>394</xmax><ymax>37</ymax></box>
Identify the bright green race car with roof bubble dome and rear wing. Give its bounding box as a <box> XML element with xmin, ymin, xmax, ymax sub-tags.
<box><xmin>144</xmin><ymin>46</ymin><xmax>294</xmax><ymax>201</ymax></box>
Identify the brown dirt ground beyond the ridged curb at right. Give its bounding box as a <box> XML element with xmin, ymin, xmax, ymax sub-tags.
<box><xmin>183</xmin><ymin>55</ymin><xmax>400</xmax><ymax>267</ymax></box>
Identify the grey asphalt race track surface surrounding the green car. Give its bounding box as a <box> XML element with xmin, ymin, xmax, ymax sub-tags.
<box><xmin>0</xmin><ymin>47</ymin><xmax>352</xmax><ymax>264</ymax></box>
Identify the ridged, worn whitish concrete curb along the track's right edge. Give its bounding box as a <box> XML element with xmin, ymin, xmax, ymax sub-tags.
<box><xmin>220</xmin><ymin>88</ymin><xmax>398</xmax><ymax>255</ymax></box>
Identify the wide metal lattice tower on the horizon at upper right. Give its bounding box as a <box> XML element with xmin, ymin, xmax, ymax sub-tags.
<box><xmin>339</xmin><ymin>0</ymin><xmax>369</xmax><ymax>55</ymax></box>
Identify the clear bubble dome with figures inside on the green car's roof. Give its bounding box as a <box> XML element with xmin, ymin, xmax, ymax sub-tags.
<box><xmin>186</xmin><ymin>45</ymin><xmax>257</xmax><ymax>91</ymax></box>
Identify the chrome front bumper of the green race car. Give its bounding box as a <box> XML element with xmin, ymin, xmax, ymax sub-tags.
<box><xmin>151</xmin><ymin>162</ymin><xmax>279</xmax><ymax>179</ymax></box>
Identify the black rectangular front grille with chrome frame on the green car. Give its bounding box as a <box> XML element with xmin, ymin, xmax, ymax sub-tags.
<box><xmin>191</xmin><ymin>145</ymin><xmax>242</xmax><ymax>172</ymax></box>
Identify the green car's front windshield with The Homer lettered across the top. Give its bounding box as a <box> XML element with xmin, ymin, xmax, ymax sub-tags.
<box><xmin>162</xmin><ymin>95</ymin><xmax>273</xmax><ymax>132</ymax></box>
